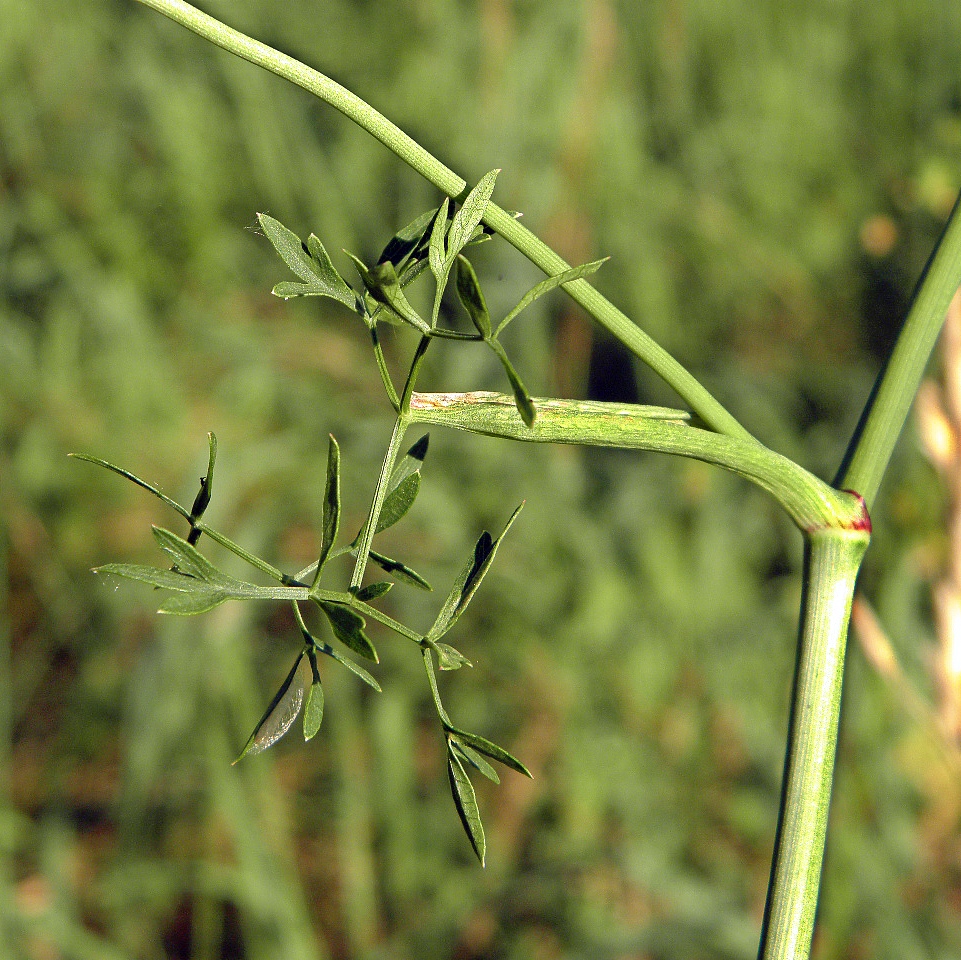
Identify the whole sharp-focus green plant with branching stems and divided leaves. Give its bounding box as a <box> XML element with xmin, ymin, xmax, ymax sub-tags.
<box><xmin>73</xmin><ymin>0</ymin><xmax>961</xmax><ymax>960</ymax></box>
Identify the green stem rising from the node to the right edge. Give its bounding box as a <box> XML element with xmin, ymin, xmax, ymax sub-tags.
<box><xmin>837</xmin><ymin>188</ymin><xmax>961</xmax><ymax>507</ymax></box>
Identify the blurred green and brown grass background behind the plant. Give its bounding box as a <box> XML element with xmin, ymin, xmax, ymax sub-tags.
<box><xmin>0</xmin><ymin>0</ymin><xmax>961</xmax><ymax>960</ymax></box>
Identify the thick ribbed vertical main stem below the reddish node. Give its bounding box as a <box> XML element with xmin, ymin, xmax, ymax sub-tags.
<box><xmin>758</xmin><ymin>529</ymin><xmax>870</xmax><ymax>960</ymax></box>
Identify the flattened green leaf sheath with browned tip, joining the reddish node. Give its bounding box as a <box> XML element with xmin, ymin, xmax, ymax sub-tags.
<box><xmin>410</xmin><ymin>393</ymin><xmax>861</xmax><ymax>532</ymax></box>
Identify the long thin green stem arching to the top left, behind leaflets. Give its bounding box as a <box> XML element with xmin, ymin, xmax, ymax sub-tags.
<box><xmin>131</xmin><ymin>0</ymin><xmax>751</xmax><ymax>440</ymax></box>
